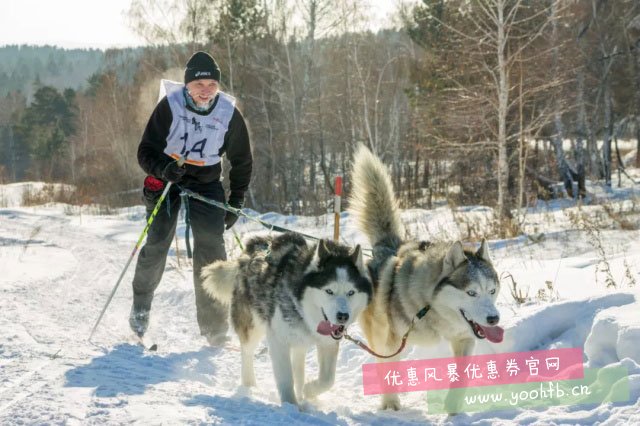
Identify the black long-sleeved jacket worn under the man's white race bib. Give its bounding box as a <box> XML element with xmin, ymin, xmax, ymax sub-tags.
<box><xmin>138</xmin><ymin>96</ymin><xmax>253</xmax><ymax>205</ymax></box>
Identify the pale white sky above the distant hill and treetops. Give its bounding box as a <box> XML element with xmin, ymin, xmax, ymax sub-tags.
<box><xmin>0</xmin><ymin>0</ymin><xmax>404</xmax><ymax>49</ymax></box>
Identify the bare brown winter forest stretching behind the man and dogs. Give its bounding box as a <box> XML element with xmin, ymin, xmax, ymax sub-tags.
<box><xmin>0</xmin><ymin>0</ymin><xmax>640</xmax><ymax>240</ymax></box>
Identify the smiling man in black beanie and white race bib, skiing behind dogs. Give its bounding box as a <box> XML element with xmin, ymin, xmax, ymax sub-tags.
<box><xmin>129</xmin><ymin>52</ymin><xmax>252</xmax><ymax>345</ymax></box>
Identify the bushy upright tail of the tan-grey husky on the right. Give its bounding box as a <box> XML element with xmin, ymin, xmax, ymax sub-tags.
<box><xmin>349</xmin><ymin>144</ymin><xmax>405</xmax><ymax>246</ymax></box>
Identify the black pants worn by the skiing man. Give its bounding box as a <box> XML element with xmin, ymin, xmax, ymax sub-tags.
<box><xmin>133</xmin><ymin>182</ymin><xmax>228</xmax><ymax>335</ymax></box>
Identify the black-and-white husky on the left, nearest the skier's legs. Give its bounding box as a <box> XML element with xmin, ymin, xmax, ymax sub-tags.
<box><xmin>202</xmin><ymin>233</ymin><xmax>372</xmax><ymax>404</ymax></box>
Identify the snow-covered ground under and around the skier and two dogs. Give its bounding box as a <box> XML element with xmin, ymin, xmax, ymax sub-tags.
<box><xmin>0</xmin><ymin>181</ymin><xmax>640</xmax><ymax>425</ymax></box>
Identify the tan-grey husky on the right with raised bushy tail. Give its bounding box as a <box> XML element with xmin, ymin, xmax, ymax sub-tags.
<box><xmin>349</xmin><ymin>146</ymin><xmax>503</xmax><ymax>413</ymax></box>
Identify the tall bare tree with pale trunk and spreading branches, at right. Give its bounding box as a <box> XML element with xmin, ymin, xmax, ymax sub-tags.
<box><xmin>416</xmin><ymin>0</ymin><xmax>560</xmax><ymax>230</ymax></box>
